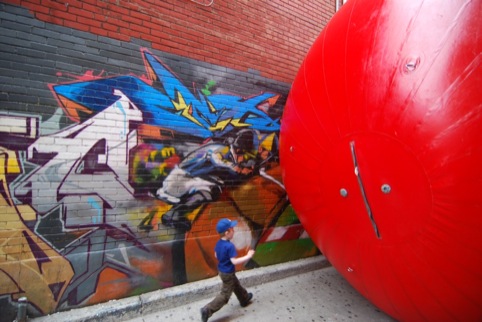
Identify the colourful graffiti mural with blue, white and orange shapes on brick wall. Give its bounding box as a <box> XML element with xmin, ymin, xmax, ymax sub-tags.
<box><xmin>0</xmin><ymin>49</ymin><xmax>317</xmax><ymax>315</ymax></box>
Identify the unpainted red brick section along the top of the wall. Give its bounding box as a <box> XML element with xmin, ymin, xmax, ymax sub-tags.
<box><xmin>6</xmin><ymin>0</ymin><xmax>335</xmax><ymax>83</ymax></box>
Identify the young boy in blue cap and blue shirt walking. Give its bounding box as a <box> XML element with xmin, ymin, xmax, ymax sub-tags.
<box><xmin>201</xmin><ymin>218</ymin><xmax>254</xmax><ymax>322</ymax></box>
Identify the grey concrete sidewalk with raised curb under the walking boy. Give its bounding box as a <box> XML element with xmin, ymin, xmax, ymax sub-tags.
<box><xmin>30</xmin><ymin>255</ymin><xmax>393</xmax><ymax>322</ymax></box>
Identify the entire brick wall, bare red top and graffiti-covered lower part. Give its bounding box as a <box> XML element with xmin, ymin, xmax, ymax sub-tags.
<box><xmin>0</xmin><ymin>0</ymin><xmax>335</xmax><ymax>321</ymax></box>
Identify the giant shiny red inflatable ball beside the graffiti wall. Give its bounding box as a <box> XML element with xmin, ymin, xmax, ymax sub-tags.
<box><xmin>280</xmin><ymin>0</ymin><xmax>482</xmax><ymax>321</ymax></box>
